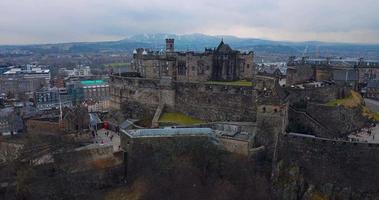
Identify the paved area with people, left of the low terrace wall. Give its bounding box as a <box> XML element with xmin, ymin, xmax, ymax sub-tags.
<box><xmin>93</xmin><ymin>129</ymin><xmax>120</xmax><ymax>152</ymax></box>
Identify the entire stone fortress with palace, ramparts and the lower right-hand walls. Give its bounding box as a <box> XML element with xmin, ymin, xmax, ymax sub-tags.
<box><xmin>110</xmin><ymin>39</ymin><xmax>379</xmax><ymax>199</ymax></box>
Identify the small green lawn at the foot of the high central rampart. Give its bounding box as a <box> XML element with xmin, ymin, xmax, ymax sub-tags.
<box><xmin>159</xmin><ymin>112</ymin><xmax>205</xmax><ymax>125</ymax></box>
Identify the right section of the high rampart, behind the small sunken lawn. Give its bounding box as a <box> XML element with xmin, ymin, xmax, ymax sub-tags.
<box><xmin>175</xmin><ymin>82</ymin><xmax>256</xmax><ymax>121</ymax></box>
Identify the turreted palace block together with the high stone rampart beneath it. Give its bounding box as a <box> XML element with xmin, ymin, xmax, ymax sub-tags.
<box><xmin>111</xmin><ymin>39</ymin><xmax>264</xmax><ymax>122</ymax></box>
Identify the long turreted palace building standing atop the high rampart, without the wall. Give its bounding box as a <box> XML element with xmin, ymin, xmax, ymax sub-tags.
<box><xmin>132</xmin><ymin>39</ymin><xmax>254</xmax><ymax>82</ymax></box>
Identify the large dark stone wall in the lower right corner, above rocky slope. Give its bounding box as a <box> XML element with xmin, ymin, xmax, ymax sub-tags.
<box><xmin>277</xmin><ymin>134</ymin><xmax>379</xmax><ymax>193</ymax></box>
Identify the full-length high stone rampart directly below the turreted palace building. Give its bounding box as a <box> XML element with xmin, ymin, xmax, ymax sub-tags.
<box><xmin>110</xmin><ymin>76</ymin><xmax>256</xmax><ymax>122</ymax></box>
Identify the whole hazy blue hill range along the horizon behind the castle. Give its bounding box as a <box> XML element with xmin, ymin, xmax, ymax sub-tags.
<box><xmin>0</xmin><ymin>33</ymin><xmax>379</xmax><ymax>61</ymax></box>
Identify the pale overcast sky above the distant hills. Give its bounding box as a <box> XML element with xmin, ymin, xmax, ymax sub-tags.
<box><xmin>0</xmin><ymin>0</ymin><xmax>379</xmax><ymax>44</ymax></box>
